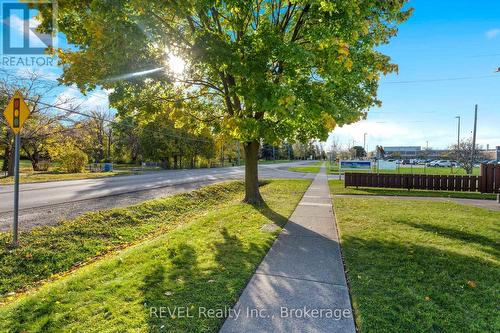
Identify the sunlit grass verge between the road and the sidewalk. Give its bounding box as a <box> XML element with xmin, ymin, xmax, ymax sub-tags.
<box><xmin>0</xmin><ymin>180</ymin><xmax>310</xmax><ymax>332</ymax></box>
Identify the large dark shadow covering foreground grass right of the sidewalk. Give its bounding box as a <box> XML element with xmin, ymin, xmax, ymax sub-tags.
<box><xmin>342</xmin><ymin>235</ymin><xmax>500</xmax><ymax>332</ymax></box>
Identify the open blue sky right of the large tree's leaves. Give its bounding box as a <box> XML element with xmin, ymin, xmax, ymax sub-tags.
<box><xmin>328</xmin><ymin>0</ymin><xmax>500</xmax><ymax>150</ymax></box>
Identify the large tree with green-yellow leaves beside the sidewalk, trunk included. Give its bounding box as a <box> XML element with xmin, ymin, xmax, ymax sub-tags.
<box><xmin>42</xmin><ymin>0</ymin><xmax>410</xmax><ymax>203</ymax></box>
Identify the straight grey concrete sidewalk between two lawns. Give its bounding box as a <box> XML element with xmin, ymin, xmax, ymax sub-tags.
<box><xmin>220</xmin><ymin>167</ymin><xmax>355</xmax><ymax>333</ymax></box>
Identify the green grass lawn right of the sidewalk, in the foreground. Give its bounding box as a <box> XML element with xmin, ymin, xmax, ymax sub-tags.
<box><xmin>334</xmin><ymin>198</ymin><xmax>500</xmax><ymax>333</ymax></box>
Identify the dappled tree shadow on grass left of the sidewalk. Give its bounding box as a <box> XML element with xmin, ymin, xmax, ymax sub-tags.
<box><xmin>141</xmin><ymin>227</ymin><xmax>272</xmax><ymax>332</ymax></box>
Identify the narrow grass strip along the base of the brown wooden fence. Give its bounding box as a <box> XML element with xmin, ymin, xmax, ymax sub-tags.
<box><xmin>328</xmin><ymin>180</ymin><xmax>496</xmax><ymax>200</ymax></box>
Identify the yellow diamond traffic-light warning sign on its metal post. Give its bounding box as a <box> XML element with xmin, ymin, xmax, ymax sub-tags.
<box><xmin>3</xmin><ymin>91</ymin><xmax>30</xmax><ymax>246</ymax></box>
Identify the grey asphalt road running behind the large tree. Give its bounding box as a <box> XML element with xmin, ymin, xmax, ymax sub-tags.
<box><xmin>0</xmin><ymin>161</ymin><xmax>314</xmax><ymax>231</ymax></box>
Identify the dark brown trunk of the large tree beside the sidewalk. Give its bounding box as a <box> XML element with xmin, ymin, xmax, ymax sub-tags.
<box><xmin>243</xmin><ymin>140</ymin><xmax>264</xmax><ymax>205</ymax></box>
